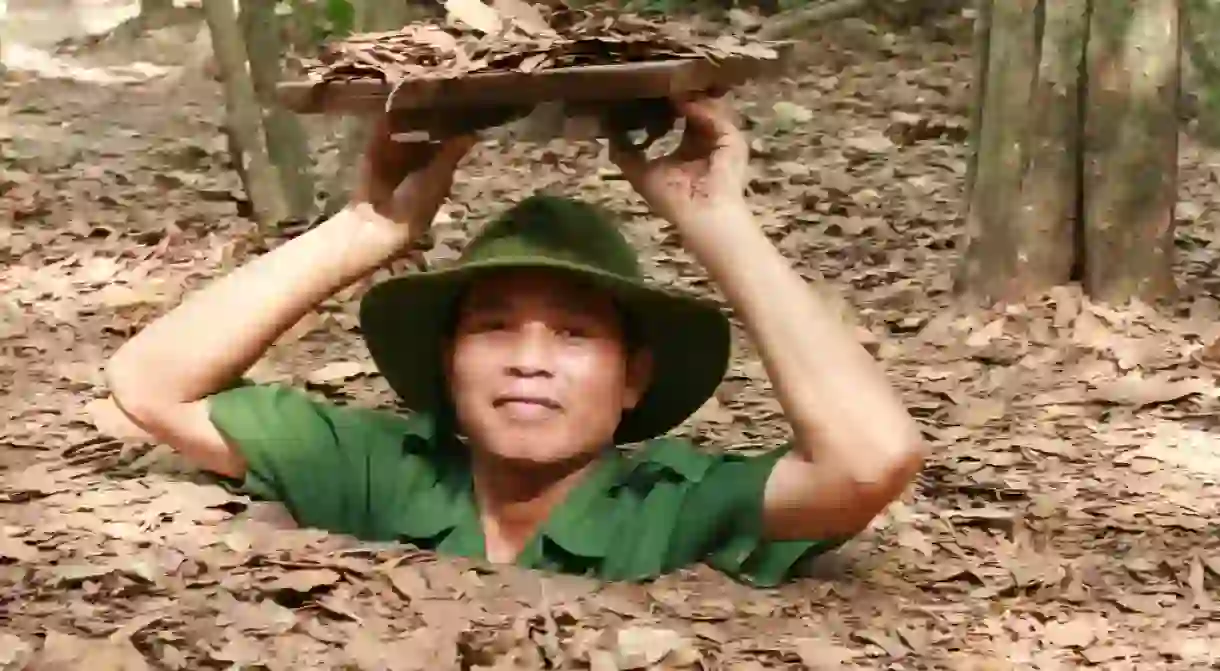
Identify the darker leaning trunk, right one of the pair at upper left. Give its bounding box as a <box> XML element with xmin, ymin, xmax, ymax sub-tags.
<box><xmin>240</xmin><ymin>0</ymin><xmax>315</xmax><ymax>221</ymax></box>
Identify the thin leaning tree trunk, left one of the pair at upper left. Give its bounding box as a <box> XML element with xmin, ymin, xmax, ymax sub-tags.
<box><xmin>204</xmin><ymin>0</ymin><xmax>288</xmax><ymax>226</ymax></box>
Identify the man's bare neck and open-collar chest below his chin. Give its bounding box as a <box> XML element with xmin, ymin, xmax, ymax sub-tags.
<box><xmin>471</xmin><ymin>450</ymin><xmax>600</xmax><ymax>564</ymax></box>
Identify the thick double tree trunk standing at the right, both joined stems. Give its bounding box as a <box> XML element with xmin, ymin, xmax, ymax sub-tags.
<box><xmin>955</xmin><ymin>0</ymin><xmax>1180</xmax><ymax>307</ymax></box>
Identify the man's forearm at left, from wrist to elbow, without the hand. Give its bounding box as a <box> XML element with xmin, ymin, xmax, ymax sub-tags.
<box><xmin>107</xmin><ymin>206</ymin><xmax>404</xmax><ymax>404</ymax></box>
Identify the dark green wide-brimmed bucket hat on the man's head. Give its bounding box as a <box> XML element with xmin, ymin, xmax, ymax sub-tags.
<box><xmin>360</xmin><ymin>194</ymin><xmax>730</xmax><ymax>444</ymax></box>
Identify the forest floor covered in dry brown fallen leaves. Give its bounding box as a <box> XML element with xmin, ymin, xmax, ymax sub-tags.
<box><xmin>0</xmin><ymin>9</ymin><xmax>1220</xmax><ymax>671</ymax></box>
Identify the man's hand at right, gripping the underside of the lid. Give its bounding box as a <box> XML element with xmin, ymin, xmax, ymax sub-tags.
<box><xmin>610</xmin><ymin>96</ymin><xmax>749</xmax><ymax>226</ymax></box>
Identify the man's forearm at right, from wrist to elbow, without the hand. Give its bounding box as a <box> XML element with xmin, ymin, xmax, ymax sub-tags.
<box><xmin>680</xmin><ymin>205</ymin><xmax>920</xmax><ymax>482</ymax></box>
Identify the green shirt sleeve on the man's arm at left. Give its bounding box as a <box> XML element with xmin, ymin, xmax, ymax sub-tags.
<box><xmin>209</xmin><ymin>384</ymin><xmax>417</xmax><ymax>537</ymax></box>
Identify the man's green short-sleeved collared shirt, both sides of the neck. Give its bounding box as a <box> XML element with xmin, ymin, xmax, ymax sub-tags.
<box><xmin>209</xmin><ymin>386</ymin><xmax>839</xmax><ymax>587</ymax></box>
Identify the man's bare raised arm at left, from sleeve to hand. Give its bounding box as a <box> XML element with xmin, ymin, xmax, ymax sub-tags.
<box><xmin>106</xmin><ymin>120</ymin><xmax>473</xmax><ymax>477</ymax></box>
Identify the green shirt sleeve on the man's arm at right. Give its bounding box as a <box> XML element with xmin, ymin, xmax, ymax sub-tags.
<box><xmin>675</xmin><ymin>445</ymin><xmax>845</xmax><ymax>587</ymax></box>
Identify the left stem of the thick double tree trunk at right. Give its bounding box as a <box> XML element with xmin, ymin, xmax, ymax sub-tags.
<box><xmin>958</xmin><ymin>0</ymin><xmax>1086</xmax><ymax>301</ymax></box>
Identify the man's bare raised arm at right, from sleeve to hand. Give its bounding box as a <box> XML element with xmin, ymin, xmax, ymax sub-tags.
<box><xmin>611</xmin><ymin>98</ymin><xmax>925</xmax><ymax>540</ymax></box>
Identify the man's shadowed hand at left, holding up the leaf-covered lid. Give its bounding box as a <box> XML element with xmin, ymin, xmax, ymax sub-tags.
<box><xmin>351</xmin><ymin>116</ymin><xmax>478</xmax><ymax>240</ymax></box>
